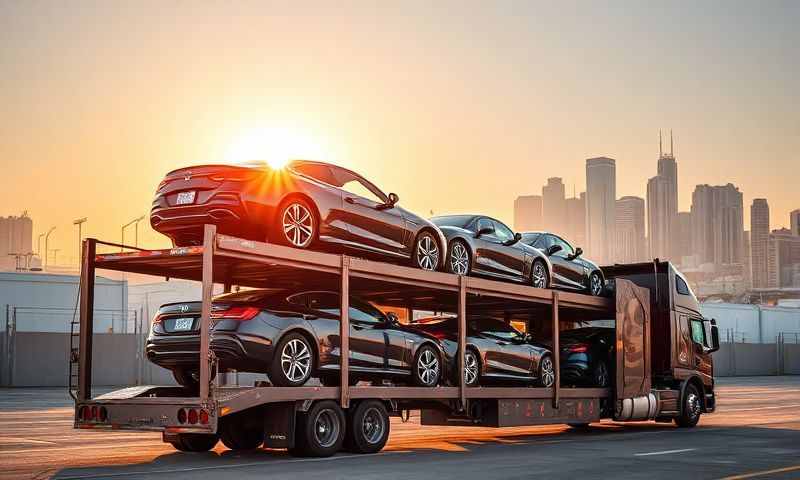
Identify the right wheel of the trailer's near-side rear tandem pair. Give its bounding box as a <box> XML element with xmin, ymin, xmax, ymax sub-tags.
<box><xmin>344</xmin><ymin>400</ymin><xmax>389</xmax><ymax>453</ymax></box>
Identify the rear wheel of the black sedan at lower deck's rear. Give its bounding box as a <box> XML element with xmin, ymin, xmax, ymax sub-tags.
<box><xmin>269</xmin><ymin>332</ymin><xmax>314</xmax><ymax>387</ymax></box>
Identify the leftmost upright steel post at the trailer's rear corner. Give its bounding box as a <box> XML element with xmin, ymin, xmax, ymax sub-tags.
<box><xmin>77</xmin><ymin>238</ymin><xmax>97</xmax><ymax>402</ymax></box>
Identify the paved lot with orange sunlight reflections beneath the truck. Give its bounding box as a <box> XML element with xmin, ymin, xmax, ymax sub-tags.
<box><xmin>0</xmin><ymin>377</ymin><xmax>800</xmax><ymax>480</ymax></box>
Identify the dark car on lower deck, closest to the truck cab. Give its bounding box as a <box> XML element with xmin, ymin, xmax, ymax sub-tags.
<box><xmin>560</xmin><ymin>327</ymin><xmax>615</xmax><ymax>387</ymax></box>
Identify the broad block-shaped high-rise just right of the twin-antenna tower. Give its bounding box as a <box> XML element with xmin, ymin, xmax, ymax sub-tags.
<box><xmin>692</xmin><ymin>183</ymin><xmax>745</xmax><ymax>266</ymax></box>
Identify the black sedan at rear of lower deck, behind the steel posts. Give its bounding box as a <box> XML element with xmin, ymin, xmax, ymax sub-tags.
<box><xmin>146</xmin><ymin>290</ymin><xmax>446</xmax><ymax>387</ymax></box>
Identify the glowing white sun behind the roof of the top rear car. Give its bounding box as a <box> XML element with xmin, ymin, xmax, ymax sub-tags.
<box><xmin>225</xmin><ymin>127</ymin><xmax>327</xmax><ymax>170</ymax></box>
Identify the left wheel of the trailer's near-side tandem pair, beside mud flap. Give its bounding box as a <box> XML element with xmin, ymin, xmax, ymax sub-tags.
<box><xmin>289</xmin><ymin>400</ymin><xmax>345</xmax><ymax>457</ymax></box>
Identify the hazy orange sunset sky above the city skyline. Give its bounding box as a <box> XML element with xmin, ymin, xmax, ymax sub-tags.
<box><xmin>0</xmin><ymin>1</ymin><xmax>800</xmax><ymax>261</ymax></box>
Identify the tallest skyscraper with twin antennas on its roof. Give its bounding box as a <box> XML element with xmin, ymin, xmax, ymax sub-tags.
<box><xmin>647</xmin><ymin>131</ymin><xmax>679</xmax><ymax>258</ymax></box>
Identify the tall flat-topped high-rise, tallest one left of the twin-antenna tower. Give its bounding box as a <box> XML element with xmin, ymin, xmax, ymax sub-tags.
<box><xmin>586</xmin><ymin>157</ymin><xmax>617</xmax><ymax>263</ymax></box>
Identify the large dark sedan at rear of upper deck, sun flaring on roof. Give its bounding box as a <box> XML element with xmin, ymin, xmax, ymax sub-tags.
<box><xmin>150</xmin><ymin>161</ymin><xmax>445</xmax><ymax>270</ymax></box>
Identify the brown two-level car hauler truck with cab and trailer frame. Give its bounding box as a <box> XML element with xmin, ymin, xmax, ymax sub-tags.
<box><xmin>70</xmin><ymin>226</ymin><xmax>718</xmax><ymax>456</ymax></box>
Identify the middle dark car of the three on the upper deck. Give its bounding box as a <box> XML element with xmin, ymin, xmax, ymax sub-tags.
<box><xmin>431</xmin><ymin>215</ymin><xmax>552</xmax><ymax>288</ymax></box>
